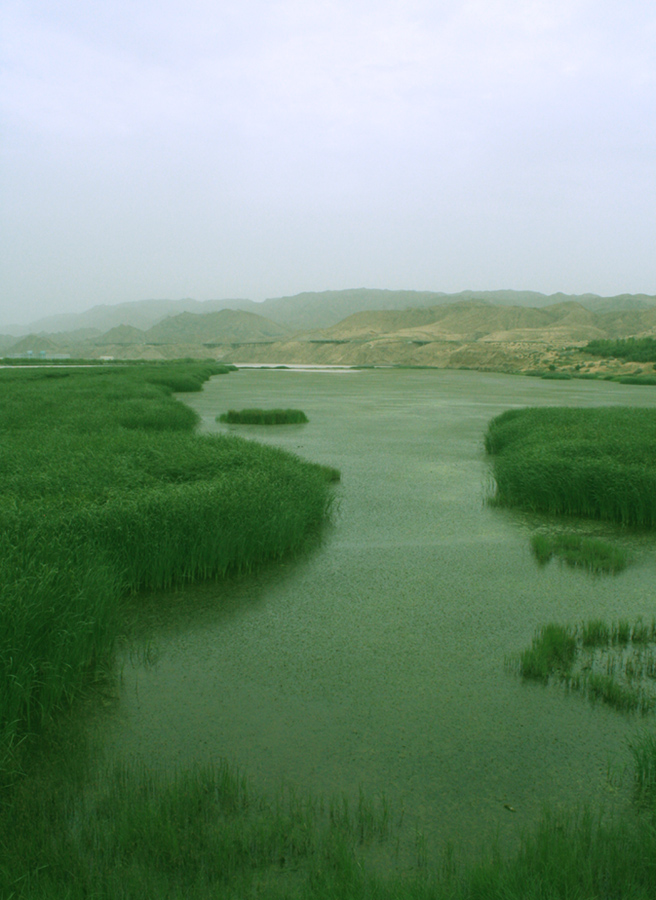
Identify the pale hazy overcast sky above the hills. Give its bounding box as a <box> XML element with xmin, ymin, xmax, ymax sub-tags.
<box><xmin>0</xmin><ymin>0</ymin><xmax>656</xmax><ymax>324</ymax></box>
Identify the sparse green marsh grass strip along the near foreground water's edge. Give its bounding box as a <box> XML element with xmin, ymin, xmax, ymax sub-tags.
<box><xmin>9</xmin><ymin>733</ymin><xmax>656</xmax><ymax>900</ymax></box>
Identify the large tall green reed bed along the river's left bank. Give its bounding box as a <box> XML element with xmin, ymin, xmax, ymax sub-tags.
<box><xmin>0</xmin><ymin>364</ymin><xmax>331</xmax><ymax>783</ymax></box>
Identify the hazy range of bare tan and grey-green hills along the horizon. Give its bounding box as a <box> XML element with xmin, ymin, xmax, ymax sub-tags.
<box><xmin>0</xmin><ymin>289</ymin><xmax>656</xmax><ymax>370</ymax></box>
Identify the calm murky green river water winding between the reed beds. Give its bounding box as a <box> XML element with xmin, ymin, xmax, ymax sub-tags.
<box><xmin>95</xmin><ymin>370</ymin><xmax>656</xmax><ymax>851</ymax></box>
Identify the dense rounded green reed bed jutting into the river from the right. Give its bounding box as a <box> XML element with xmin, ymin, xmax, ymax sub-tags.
<box><xmin>485</xmin><ymin>406</ymin><xmax>656</xmax><ymax>528</ymax></box>
